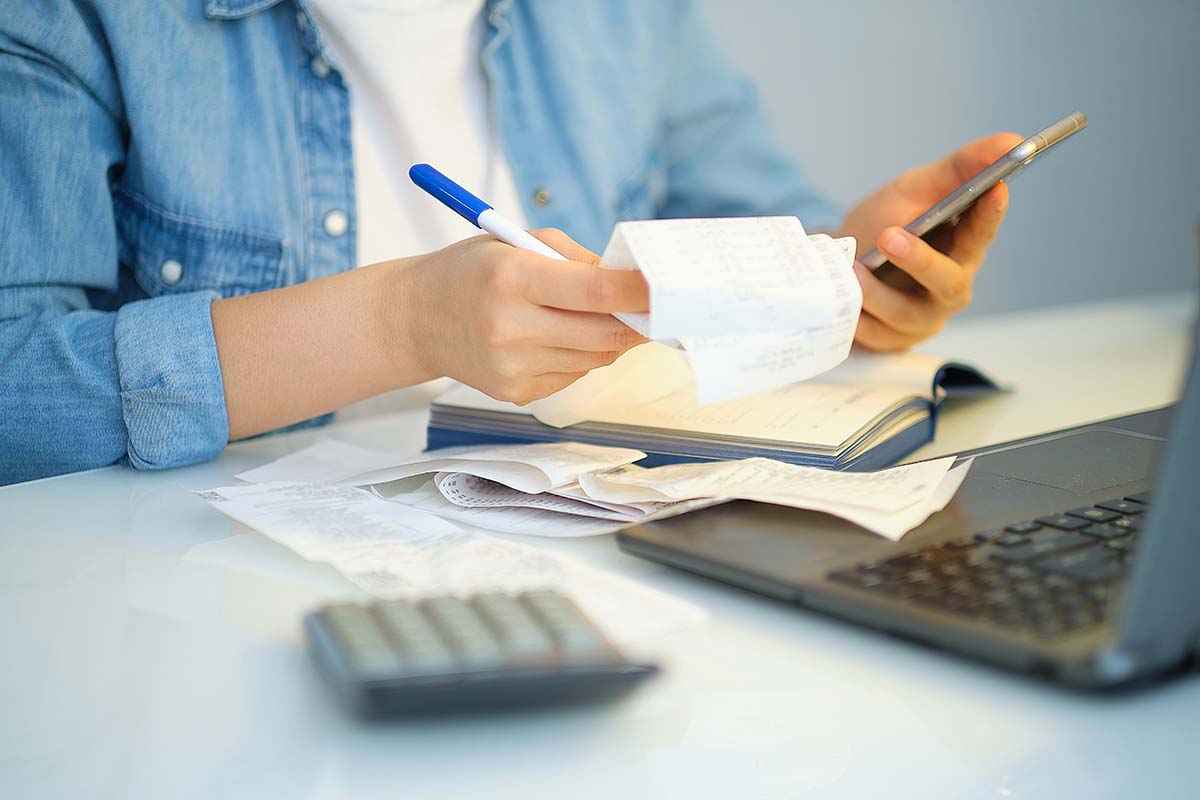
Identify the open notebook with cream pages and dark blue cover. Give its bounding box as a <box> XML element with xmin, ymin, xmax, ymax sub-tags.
<box><xmin>427</xmin><ymin>344</ymin><xmax>998</xmax><ymax>470</ymax></box>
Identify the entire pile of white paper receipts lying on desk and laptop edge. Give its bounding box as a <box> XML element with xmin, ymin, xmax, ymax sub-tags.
<box><xmin>197</xmin><ymin>440</ymin><xmax>970</xmax><ymax>644</ymax></box>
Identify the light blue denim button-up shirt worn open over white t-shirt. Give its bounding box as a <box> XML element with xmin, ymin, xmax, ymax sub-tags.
<box><xmin>0</xmin><ymin>0</ymin><xmax>838</xmax><ymax>483</ymax></box>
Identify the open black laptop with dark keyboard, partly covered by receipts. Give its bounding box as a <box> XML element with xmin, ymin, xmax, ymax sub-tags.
<box><xmin>618</xmin><ymin>331</ymin><xmax>1200</xmax><ymax>690</ymax></box>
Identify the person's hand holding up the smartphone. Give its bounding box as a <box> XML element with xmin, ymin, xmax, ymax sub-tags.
<box><xmin>844</xmin><ymin>133</ymin><xmax>1021</xmax><ymax>350</ymax></box>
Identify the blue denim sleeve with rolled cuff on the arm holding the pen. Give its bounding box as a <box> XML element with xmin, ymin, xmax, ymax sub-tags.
<box><xmin>0</xmin><ymin>14</ymin><xmax>228</xmax><ymax>483</ymax></box>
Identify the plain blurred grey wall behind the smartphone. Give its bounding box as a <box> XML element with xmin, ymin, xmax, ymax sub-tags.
<box><xmin>701</xmin><ymin>0</ymin><xmax>1200</xmax><ymax>312</ymax></box>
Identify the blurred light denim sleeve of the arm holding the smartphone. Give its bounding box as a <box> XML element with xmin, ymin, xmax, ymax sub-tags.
<box><xmin>659</xmin><ymin>0</ymin><xmax>842</xmax><ymax>230</ymax></box>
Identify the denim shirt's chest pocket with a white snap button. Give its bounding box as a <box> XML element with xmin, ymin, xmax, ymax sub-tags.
<box><xmin>113</xmin><ymin>190</ymin><xmax>283</xmax><ymax>297</ymax></box>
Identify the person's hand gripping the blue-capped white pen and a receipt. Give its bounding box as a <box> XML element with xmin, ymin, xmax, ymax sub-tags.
<box><xmin>385</xmin><ymin>229</ymin><xmax>649</xmax><ymax>404</ymax></box>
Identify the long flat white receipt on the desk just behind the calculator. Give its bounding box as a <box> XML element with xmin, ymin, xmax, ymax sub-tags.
<box><xmin>198</xmin><ymin>483</ymin><xmax>704</xmax><ymax>644</ymax></box>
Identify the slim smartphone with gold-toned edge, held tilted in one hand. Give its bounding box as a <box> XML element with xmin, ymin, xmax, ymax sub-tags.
<box><xmin>858</xmin><ymin>112</ymin><xmax>1087</xmax><ymax>289</ymax></box>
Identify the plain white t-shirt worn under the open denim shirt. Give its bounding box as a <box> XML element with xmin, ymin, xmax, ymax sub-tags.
<box><xmin>304</xmin><ymin>0</ymin><xmax>524</xmax><ymax>420</ymax></box>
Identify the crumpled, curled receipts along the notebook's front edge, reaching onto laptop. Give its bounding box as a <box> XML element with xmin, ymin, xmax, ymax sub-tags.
<box><xmin>226</xmin><ymin>440</ymin><xmax>970</xmax><ymax>540</ymax></box>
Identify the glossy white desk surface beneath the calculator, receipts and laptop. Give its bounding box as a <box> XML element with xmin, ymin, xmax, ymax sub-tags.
<box><xmin>0</xmin><ymin>297</ymin><xmax>1200</xmax><ymax>800</ymax></box>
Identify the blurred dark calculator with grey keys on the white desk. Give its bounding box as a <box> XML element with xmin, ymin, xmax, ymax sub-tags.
<box><xmin>305</xmin><ymin>590</ymin><xmax>658</xmax><ymax>718</ymax></box>
